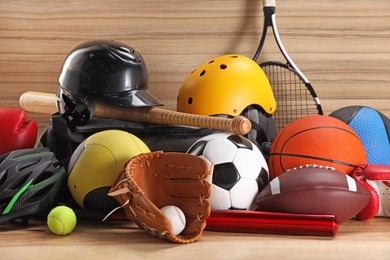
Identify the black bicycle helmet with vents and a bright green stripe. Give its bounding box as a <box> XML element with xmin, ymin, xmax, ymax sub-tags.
<box><xmin>0</xmin><ymin>148</ymin><xmax>66</xmax><ymax>222</ymax></box>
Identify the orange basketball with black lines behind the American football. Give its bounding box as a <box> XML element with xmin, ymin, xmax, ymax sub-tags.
<box><xmin>268</xmin><ymin>115</ymin><xmax>367</xmax><ymax>179</ymax></box>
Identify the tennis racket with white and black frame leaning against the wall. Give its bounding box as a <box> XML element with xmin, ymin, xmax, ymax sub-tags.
<box><xmin>253</xmin><ymin>0</ymin><xmax>323</xmax><ymax>131</ymax></box>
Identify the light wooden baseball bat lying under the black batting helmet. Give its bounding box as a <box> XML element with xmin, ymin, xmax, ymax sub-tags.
<box><xmin>19</xmin><ymin>91</ymin><xmax>252</xmax><ymax>135</ymax></box>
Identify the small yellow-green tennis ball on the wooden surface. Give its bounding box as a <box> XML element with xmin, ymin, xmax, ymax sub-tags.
<box><xmin>47</xmin><ymin>206</ymin><xmax>77</xmax><ymax>236</ymax></box>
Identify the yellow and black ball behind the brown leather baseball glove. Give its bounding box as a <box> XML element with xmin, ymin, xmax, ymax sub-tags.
<box><xmin>68</xmin><ymin>130</ymin><xmax>150</xmax><ymax>212</ymax></box>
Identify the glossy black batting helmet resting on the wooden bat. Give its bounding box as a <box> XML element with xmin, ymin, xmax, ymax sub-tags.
<box><xmin>57</xmin><ymin>40</ymin><xmax>161</xmax><ymax>123</ymax></box>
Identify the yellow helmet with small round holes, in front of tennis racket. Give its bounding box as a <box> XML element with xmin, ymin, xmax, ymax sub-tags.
<box><xmin>177</xmin><ymin>54</ymin><xmax>276</xmax><ymax>116</ymax></box>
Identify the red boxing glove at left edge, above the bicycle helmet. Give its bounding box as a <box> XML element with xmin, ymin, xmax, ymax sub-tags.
<box><xmin>0</xmin><ymin>108</ymin><xmax>38</xmax><ymax>154</ymax></box>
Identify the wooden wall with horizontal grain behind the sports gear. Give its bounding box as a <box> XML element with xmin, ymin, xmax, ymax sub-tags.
<box><xmin>0</xmin><ymin>0</ymin><xmax>390</xmax><ymax>136</ymax></box>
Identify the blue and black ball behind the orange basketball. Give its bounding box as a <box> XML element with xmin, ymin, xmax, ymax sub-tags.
<box><xmin>330</xmin><ymin>106</ymin><xmax>390</xmax><ymax>165</ymax></box>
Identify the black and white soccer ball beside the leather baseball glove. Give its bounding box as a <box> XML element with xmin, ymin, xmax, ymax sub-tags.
<box><xmin>187</xmin><ymin>133</ymin><xmax>269</xmax><ymax>210</ymax></box>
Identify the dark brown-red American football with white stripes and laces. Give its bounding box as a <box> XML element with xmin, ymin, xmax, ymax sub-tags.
<box><xmin>256</xmin><ymin>166</ymin><xmax>370</xmax><ymax>224</ymax></box>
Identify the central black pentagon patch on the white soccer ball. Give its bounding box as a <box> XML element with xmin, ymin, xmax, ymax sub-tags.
<box><xmin>212</xmin><ymin>162</ymin><xmax>241</xmax><ymax>190</ymax></box>
